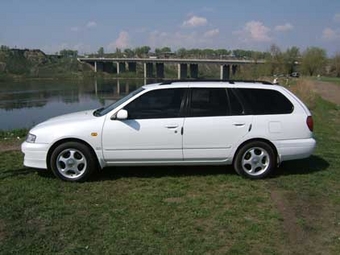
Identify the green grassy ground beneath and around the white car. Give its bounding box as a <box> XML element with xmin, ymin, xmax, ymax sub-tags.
<box><xmin>0</xmin><ymin>80</ymin><xmax>340</xmax><ymax>254</ymax></box>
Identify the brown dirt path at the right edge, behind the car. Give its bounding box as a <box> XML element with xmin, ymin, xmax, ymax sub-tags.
<box><xmin>313</xmin><ymin>81</ymin><xmax>340</xmax><ymax>105</ymax></box>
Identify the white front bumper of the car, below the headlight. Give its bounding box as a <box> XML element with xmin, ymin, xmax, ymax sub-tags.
<box><xmin>21</xmin><ymin>142</ymin><xmax>49</xmax><ymax>169</ymax></box>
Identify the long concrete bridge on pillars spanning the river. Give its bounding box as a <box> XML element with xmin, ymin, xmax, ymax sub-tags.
<box><xmin>78</xmin><ymin>58</ymin><xmax>265</xmax><ymax>80</ymax></box>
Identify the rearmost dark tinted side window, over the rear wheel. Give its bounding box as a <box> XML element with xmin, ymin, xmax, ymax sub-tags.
<box><xmin>234</xmin><ymin>88</ymin><xmax>294</xmax><ymax>115</ymax></box>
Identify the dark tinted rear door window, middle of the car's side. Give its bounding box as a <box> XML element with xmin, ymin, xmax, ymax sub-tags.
<box><xmin>189</xmin><ymin>88</ymin><xmax>230</xmax><ymax>117</ymax></box>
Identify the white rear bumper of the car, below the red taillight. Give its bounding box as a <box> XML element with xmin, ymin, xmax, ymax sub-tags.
<box><xmin>274</xmin><ymin>138</ymin><xmax>316</xmax><ymax>162</ymax></box>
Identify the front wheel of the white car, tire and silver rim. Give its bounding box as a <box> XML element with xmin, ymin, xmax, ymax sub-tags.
<box><xmin>50</xmin><ymin>142</ymin><xmax>98</xmax><ymax>182</ymax></box>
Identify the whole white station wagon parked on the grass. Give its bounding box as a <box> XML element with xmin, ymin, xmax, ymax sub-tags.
<box><xmin>22</xmin><ymin>81</ymin><xmax>315</xmax><ymax>182</ymax></box>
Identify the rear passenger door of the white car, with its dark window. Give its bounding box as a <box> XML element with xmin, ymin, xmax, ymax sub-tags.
<box><xmin>183</xmin><ymin>88</ymin><xmax>252</xmax><ymax>161</ymax></box>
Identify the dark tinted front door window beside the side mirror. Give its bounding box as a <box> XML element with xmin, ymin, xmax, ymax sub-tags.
<box><xmin>124</xmin><ymin>89</ymin><xmax>185</xmax><ymax>119</ymax></box>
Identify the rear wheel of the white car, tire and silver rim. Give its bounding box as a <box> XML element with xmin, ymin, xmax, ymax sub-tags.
<box><xmin>234</xmin><ymin>141</ymin><xmax>276</xmax><ymax>179</ymax></box>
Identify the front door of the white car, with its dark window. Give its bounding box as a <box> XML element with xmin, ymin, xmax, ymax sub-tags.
<box><xmin>102</xmin><ymin>88</ymin><xmax>185</xmax><ymax>163</ymax></box>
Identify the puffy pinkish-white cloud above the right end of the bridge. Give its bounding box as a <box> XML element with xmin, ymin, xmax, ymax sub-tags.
<box><xmin>233</xmin><ymin>21</ymin><xmax>272</xmax><ymax>42</ymax></box>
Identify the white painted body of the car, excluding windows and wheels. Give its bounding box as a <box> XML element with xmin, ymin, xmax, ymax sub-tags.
<box><xmin>22</xmin><ymin>81</ymin><xmax>315</xmax><ymax>180</ymax></box>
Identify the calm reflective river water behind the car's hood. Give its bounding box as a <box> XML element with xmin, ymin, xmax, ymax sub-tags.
<box><xmin>0</xmin><ymin>80</ymin><xmax>153</xmax><ymax>130</ymax></box>
